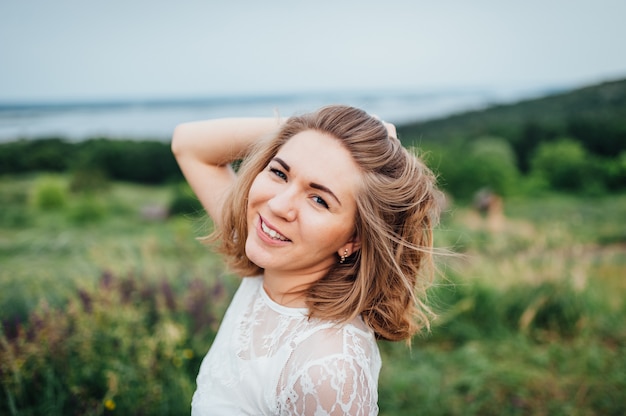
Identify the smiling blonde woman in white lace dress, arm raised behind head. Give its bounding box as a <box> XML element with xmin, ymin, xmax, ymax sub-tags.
<box><xmin>172</xmin><ymin>106</ymin><xmax>438</xmax><ymax>415</ymax></box>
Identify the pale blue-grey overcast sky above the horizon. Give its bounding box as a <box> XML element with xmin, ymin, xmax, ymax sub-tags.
<box><xmin>0</xmin><ymin>0</ymin><xmax>626</xmax><ymax>102</ymax></box>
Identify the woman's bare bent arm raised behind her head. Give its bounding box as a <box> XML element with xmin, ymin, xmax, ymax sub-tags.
<box><xmin>172</xmin><ymin>117</ymin><xmax>282</xmax><ymax>221</ymax></box>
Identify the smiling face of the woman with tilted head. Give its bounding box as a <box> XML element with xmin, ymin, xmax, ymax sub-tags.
<box><xmin>246</xmin><ymin>130</ymin><xmax>360</xmax><ymax>274</ymax></box>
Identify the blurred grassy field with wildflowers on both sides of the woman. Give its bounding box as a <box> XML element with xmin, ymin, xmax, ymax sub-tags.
<box><xmin>0</xmin><ymin>171</ymin><xmax>626</xmax><ymax>415</ymax></box>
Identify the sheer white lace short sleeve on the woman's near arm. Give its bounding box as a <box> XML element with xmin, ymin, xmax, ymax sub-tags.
<box><xmin>279</xmin><ymin>357</ymin><xmax>378</xmax><ymax>416</ymax></box>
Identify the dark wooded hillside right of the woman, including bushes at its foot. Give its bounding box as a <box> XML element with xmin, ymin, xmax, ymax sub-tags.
<box><xmin>398</xmin><ymin>80</ymin><xmax>626</xmax><ymax>197</ymax></box>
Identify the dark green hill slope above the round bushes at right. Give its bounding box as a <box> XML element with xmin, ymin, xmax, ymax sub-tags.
<box><xmin>398</xmin><ymin>79</ymin><xmax>626</xmax><ymax>169</ymax></box>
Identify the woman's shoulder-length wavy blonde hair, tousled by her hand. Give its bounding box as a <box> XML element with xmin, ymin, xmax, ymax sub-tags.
<box><xmin>211</xmin><ymin>106</ymin><xmax>440</xmax><ymax>341</ymax></box>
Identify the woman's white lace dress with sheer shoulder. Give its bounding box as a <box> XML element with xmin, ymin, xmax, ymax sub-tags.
<box><xmin>191</xmin><ymin>277</ymin><xmax>381</xmax><ymax>416</ymax></box>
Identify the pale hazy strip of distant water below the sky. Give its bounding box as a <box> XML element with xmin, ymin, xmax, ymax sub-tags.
<box><xmin>0</xmin><ymin>91</ymin><xmax>528</xmax><ymax>142</ymax></box>
